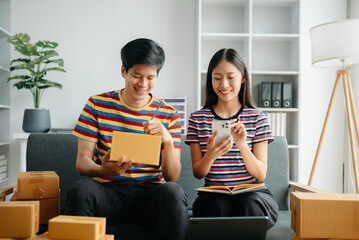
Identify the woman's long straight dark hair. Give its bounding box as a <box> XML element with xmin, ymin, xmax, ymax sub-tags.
<box><xmin>203</xmin><ymin>48</ymin><xmax>255</xmax><ymax>108</ymax></box>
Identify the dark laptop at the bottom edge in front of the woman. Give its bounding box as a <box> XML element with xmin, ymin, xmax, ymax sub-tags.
<box><xmin>187</xmin><ymin>216</ymin><xmax>269</xmax><ymax>240</ymax></box>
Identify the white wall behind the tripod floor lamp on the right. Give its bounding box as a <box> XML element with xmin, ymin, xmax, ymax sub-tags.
<box><xmin>298</xmin><ymin>0</ymin><xmax>347</xmax><ymax>192</ymax></box>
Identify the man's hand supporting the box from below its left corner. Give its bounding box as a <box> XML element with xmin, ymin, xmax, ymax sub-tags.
<box><xmin>101</xmin><ymin>150</ymin><xmax>137</xmax><ymax>176</ymax></box>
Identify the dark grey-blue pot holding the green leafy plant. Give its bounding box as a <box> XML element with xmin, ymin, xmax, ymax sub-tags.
<box><xmin>22</xmin><ymin>109</ymin><xmax>51</xmax><ymax>133</ymax></box>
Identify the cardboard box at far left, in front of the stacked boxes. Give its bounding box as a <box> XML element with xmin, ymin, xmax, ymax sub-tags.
<box><xmin>0</xmin><ymin>201</ymin><xmax>39</xmax><ymax>238</ymax></box>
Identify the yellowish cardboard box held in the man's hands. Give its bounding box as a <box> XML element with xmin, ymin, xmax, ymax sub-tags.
<box><xmin>110</xmin><ymin>131</ymin><xmax>161</xmax><ymax>166</ymax></box>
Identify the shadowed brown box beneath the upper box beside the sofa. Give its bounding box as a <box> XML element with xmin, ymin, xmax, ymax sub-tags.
<box><xmin>10</xmin><ymin>190</ymin><xmax>60</xmax><ymax>224</ymax></box>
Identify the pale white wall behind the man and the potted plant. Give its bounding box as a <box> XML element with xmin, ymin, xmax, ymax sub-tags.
<box><xmin>9</xmin><ymin>0</ymin><xmax>196</xmax><ymax>182</ymax></box>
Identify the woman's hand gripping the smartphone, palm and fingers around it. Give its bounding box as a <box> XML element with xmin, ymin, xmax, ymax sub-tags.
<box><xmin>206</xmin><ymin>132</ymin><xmax>233</xmax><ymax>160</ymax></box>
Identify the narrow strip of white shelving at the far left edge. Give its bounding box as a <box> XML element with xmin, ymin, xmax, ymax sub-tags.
<box><xmin>0</xmin><ymin>0</ymin><xmax>11</xmax><ymax>186</ymax></box>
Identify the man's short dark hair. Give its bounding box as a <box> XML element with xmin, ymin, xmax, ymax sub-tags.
<box><xmin>121</xmin><ymin>38</ymin><xmax>165</xmax><ymax>73</ymax></box>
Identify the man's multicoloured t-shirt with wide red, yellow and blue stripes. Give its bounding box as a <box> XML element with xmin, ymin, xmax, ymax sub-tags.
<box><xmin>73</xmin><ymin>90</ymin><xmax>181</xmax><ymax>183</ymax></box>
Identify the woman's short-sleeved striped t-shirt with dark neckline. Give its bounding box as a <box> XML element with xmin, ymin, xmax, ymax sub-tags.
<box><xmin>186</xmin><ymin>107</ymin><xmax>273</xmax><ymax>187</ymax></box>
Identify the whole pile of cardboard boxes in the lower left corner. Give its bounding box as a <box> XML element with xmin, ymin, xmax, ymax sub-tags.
<box><xmin>0</xmin><ymin>171</ymin><xmax>114</xmax><ymax>240</ymax></box>
